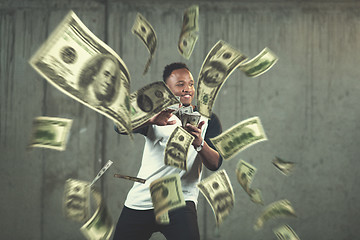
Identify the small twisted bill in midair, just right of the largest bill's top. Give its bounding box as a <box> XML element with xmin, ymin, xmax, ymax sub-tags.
<box><xmin>131</xmin><ymin>13</ymin><xmax>157</xmax><ymax>74</ymax></box>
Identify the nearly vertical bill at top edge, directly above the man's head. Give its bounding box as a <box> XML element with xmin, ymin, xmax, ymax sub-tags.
<box><xmin>178</xmin><ymin>5</ymin><xmax>199</xmax><ymax>59</ymax></box>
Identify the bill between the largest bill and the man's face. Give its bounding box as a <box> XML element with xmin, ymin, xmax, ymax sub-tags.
<box><xmin>117</xmin><ymin>81</ymin><xmax>179</xmax><ymax>133</ymax></box>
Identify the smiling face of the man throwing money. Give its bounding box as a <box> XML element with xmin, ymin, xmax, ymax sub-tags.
<box><xmin>166</xmin><ymin>68</ymin><xmax>195</xmax><ymax>106</ymax></box>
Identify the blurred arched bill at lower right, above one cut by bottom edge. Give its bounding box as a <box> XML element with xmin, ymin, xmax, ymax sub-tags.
<box><xmin>254</xmin><ymin>199</ymin><xmax>296</xmax><ymax>230</ymax></box>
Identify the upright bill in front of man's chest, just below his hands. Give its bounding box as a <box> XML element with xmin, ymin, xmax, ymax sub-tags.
<box><xmin>164</xmin><ymin>126</ymin><xmax>194</xmax><ymax>171</ymax></box>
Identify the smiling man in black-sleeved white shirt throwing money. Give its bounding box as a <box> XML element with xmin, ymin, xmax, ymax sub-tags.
<box><xmin>114</xmin><ymin>63</ymin><xmax>222</xmax><ymax>240</ymax></box>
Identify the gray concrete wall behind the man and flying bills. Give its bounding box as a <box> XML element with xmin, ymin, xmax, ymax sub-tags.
<box><xmin>0</xmin><ymin>0</ymin><xmax>360</xmax><ymax>240</ymax></box>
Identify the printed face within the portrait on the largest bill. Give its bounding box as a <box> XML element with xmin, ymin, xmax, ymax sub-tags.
<box><xmin>94</xmin><ymin>59</ymin><xmax>116</xmax><ymax>96</ymax></box>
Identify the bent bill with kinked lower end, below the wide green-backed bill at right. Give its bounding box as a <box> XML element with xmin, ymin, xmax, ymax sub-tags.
<box><xmin>236</xmin><ymin>160</ymin><xmax>264</xmax><ymax>204</ymax></box>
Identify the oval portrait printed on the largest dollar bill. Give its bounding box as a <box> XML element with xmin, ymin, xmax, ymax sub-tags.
<box><xmin>79</xmin><ymin>55</ymin><xmax>120</xmax><ymax>106</ymax></box>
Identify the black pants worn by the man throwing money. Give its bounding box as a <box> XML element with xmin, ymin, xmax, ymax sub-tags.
<box><xmin>113</xmin><ymin>201</ymin><xmax>200</xmax><ymax>240</ymax></box>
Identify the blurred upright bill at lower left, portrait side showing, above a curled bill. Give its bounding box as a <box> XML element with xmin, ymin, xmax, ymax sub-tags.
<box><xmin>63</xmin><ymin>178</ymin><xmax>90</xmax><ymax>222</ymax></box>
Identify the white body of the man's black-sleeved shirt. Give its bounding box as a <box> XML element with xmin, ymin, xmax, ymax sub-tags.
<box><xmin>125</xmin><ymin>115</ymin><xmax>208</xmax><ymax>210</ymax></box>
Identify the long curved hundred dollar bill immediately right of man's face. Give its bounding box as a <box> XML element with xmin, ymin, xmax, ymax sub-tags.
<box><xmin>197</xmin><ymin>40</ymin><xmax>246</xmax><ymax>118</ymax></box>
